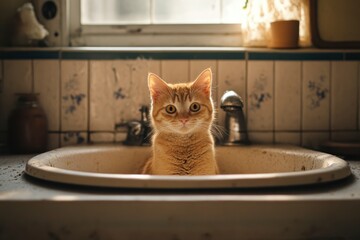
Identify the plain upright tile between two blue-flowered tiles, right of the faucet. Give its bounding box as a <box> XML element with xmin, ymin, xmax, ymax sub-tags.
<box><xmin>274</xmin><ymin>61</ymin><xmax>301</xmax><ymax>131</ymax></box>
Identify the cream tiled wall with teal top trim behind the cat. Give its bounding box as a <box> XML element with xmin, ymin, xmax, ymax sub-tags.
<box><xmin>0</xmin><ymin>51</ymin><xmax>360</xmax><ymax>149</ymax></box>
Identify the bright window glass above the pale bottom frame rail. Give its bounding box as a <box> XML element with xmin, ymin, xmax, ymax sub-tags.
<box><xmin>81</xmin><ymin>0</ymin><xmax>244</xmax><ymax>25</ymax></box>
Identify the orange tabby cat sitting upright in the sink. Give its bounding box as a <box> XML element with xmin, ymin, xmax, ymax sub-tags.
<box><xmin>142</xmin><ymin>68</ymin><xmax>218</xmax><ymax>175</ymax></box>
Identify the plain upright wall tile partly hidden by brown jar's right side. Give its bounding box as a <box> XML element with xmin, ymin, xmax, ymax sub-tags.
<box><xmin>33</xmin><ymin>60</ymin><xmax>60</xmax><ymax>131</ymax></box>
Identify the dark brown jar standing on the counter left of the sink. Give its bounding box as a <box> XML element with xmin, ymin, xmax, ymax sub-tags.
<box><xmin>8</xmin><ymin>93</ymin><xmax>47</xmax><ymax>153</ymax></box>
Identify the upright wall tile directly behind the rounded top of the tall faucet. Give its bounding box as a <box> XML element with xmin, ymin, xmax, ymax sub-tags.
<box><xmin>216</xmin><ymin>60</ymin><xmax>246</xmax><ymax>131</ymax></box>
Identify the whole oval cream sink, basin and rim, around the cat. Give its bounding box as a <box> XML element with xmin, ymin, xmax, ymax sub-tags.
<box><xmin>26</xmin><ymin>145</ymin><xmax>351</xmax><ymax>188</ymax></box>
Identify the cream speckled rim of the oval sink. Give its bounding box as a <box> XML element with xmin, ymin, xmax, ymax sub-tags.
<box><xmin>25</xmin><ymin>145</ymin><xmax>352</xmax><ymax>189</ymax></box>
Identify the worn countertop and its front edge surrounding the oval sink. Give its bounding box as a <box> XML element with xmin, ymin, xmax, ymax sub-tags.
<box><xmin>0</xmin><ymin>155</ymin><xmax>360</xmax><ymax>239</ymax></box>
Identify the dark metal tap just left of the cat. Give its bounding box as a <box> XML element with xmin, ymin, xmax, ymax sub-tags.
<box><xmin>124</xmin><ymin>106</ymin><xmax>151</xmax><ymax>146</ymax></box>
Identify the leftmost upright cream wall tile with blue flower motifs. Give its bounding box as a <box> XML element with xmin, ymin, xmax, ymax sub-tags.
<box><xmin>61</xmin><ymin>60</ymin><xmax>89</xmax><ymax>131</ymax></box>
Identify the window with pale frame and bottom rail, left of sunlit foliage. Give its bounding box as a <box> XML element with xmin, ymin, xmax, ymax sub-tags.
<box><xmin>70</xmin><ymin>0</ymin><xmax>245</xmax><ymax>46</ymax></box>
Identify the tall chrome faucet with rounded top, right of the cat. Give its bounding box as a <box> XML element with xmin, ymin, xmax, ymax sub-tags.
<box><xmin>220</xmin><ymin>91</ymin><xmax>250</xmax><ymax>145</ymax></box>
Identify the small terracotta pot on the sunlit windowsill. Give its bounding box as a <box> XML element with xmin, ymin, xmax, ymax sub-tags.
<box><xmin>269</xmin><ymin>20</ymin><xmax>299</xmax><ymax>48</ymax></box>
